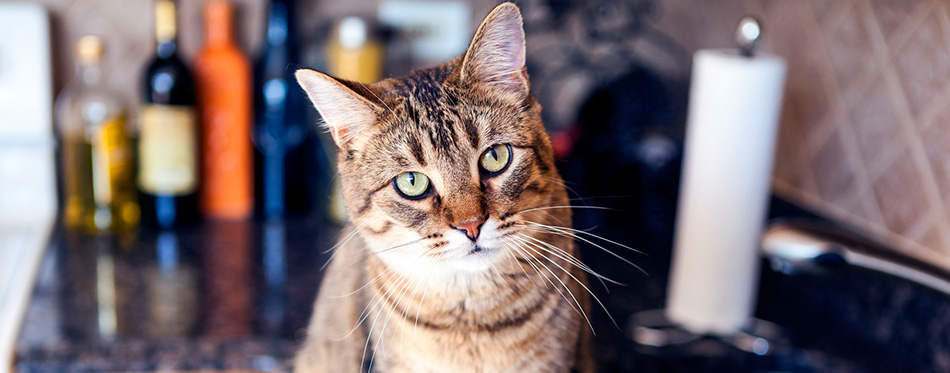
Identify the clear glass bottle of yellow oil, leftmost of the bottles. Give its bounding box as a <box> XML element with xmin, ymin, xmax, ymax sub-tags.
<box><xmin>56</xmin><ymin>36</ymin><xmax>139</xmax><ymax>233</ymax></box>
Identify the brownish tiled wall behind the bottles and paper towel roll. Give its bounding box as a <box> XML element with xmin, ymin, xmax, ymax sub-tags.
<box><xmin>18</xmin><ymin>0</ymin><xmax>950</xmax><ymax>267</ymax></box>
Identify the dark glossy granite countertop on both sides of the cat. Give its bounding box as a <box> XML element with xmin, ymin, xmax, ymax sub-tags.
<box><xmin>15</xmin><ymin>200</ymin><xmax>950</xmax><ymax>372</ymax></box>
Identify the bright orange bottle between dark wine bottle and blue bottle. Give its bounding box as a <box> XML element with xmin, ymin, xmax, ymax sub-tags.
<box><xmin>195</xmin><ymin>0</ymin><xmax>254</xmax><ymax>219</ymax></box>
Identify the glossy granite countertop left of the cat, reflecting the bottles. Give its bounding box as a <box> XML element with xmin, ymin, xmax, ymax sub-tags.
<box><xmin>16</xmin><ymin>219</ymin><xmax>338</xmax><ymax>371</ymax></box>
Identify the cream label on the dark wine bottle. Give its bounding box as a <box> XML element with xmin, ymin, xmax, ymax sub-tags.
<box><xmin>139</xmin><ymin>105</ymin><xmax>198</xmax><ymax>196</ymax></box>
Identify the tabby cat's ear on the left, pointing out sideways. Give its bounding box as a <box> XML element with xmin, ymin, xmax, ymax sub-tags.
<box><xmin>295</xmin><ymin>69</ymin><xmax>379</xmax><ymax>147</ymax></box>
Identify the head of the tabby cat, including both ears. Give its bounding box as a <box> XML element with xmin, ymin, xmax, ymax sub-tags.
<box><xmin>297</xmin><ymin>3</ymin><xmax>570</xmax><ymax>280</ymax></box>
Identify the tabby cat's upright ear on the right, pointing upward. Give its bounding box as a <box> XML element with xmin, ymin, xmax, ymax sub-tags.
<box><xmin>461</xmin><ymin>3</ymin><xmax>528</xmax><ymax>95</ymax></box>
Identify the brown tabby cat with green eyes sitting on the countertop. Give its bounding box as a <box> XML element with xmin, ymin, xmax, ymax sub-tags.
<box><xmin>294</xmin><ymin>3</ymin><xmax>594</xmax><ymax>372</ymax></box>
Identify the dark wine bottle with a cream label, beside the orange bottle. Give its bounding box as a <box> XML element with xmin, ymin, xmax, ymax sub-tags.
<box><xmin>138</xmin><ymin>0</ymin><xmax>198</xmax><ymax>228</ymax></box>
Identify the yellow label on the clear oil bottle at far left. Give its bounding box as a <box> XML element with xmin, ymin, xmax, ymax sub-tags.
<box><xmin>92</xmin><ymin>114</ymin><xmax>132</xmax><ymax>206</ymax></box>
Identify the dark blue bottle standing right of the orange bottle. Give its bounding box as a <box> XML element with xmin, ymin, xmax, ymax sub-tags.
<box><xmin>253</xmin><ymin>0</ymin><xmax>314</xmax><ymax>218</ymax></box>
